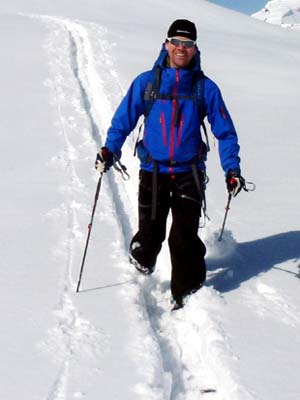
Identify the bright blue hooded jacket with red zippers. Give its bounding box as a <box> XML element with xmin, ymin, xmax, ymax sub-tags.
<box><xmin>105</xmin><ymin>45</ymin><xmax>240</xmax><ymax>174</ymax></box>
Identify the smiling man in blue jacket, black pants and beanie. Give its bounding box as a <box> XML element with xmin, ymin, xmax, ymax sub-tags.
<box><xmin>96</xmin><ymin>20</ymin><xmax>244</xmax><ymax>309</ymax></box>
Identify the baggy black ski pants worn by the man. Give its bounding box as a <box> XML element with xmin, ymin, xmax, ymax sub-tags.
<box><xmin>130</xmin><ymin>170</ymin><xmax>206</xmax><ymax>300</ymax></box>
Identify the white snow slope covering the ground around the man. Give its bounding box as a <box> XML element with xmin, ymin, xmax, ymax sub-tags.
<box><xmin>0</xmin><ymin>0</ymin><xmax>300</xmax><ymax>400</ymax></box>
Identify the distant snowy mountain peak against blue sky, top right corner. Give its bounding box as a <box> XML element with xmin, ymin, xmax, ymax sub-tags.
<box><xmin>252</xmin><ymin>0</ymin><xmax>300</xmax><ymax>29</ymax></box>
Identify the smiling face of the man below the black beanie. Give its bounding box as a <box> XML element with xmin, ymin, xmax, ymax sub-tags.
<box><xmin>166</xmin><ymin>36</ymin><xmax>196</xmax><ymax>68</ymax></box>
